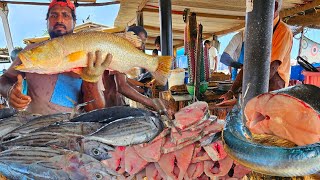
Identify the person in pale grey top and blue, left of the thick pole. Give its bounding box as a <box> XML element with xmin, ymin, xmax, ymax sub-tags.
<box><xmin>220</xmin><ymin>31</ymin><xmax>244</xmax><ymax>81</ymax></box>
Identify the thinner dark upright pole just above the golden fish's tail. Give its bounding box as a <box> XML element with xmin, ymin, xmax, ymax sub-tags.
<box><xmin>159</xmin><ymin>0</ymin><xmax>173</xmax><ymax>56</ymax></box>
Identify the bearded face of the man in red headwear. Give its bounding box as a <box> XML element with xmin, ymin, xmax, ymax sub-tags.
<box><xmin>47</xmin><ymin>5</ymin><xmax>75</xmax><ymax>38</ymax></box>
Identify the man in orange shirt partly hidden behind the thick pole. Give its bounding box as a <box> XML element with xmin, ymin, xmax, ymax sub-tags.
<box><xmin>221</xmin><ymin>0</ymin><xmax>293</xmax><ymax>100</ymax></box>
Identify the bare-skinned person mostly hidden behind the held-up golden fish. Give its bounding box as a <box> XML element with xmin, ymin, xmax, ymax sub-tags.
<box><xmin>103</xmin><ymin>26</ymin><xmax>156</xmax><ymax>109</ymax></box>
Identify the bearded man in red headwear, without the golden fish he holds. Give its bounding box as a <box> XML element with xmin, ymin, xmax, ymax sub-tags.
<box><xmin>0</xmin><ymin>0</ymin><xmax>112</xmax><ymax>114</ymax></box>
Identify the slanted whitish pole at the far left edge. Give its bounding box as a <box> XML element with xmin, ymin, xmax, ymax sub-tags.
<box><xmin>0</xmin><ymin>2</ymin><xmax>14</xmax><ymax>62</ymax></box>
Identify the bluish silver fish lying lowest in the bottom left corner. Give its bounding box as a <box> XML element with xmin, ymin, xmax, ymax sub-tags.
<box><xmin>0</xmin><ymin>147</ymin><xmax>117</xmax><ymax>180</ymax></box>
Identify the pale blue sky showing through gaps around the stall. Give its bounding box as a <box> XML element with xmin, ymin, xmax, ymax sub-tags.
<box><xmin>0</xmin><ymin>0</ymin><xmax>320</xmax><ymax>62</ymax></box>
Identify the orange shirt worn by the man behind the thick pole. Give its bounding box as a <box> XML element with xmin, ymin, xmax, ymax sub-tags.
<box><xmin>271</xmin><ymin>16</ymin><xmax>293</xmax><ymax>87</ymax></box>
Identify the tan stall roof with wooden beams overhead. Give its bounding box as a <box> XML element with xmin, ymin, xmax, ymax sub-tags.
<box><xmin>115</xmin><ymin>0</ymin><xmax>320</xmax><ymax>48</ymax></box>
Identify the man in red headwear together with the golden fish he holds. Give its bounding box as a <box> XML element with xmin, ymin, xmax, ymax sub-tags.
<box><xmin>0</xmin><ymin>0</ymin><xmax>172</xmax><ymax>114</ymax></box>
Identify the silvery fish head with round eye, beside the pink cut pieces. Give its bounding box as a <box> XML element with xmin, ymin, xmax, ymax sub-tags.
<box><xmin>84</xmin><ymin>140</ymin><xmax>114</xmax><ymax>161</ymax></box>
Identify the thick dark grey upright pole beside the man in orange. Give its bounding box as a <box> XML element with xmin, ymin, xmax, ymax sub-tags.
<box><xmin>242</xmin><ymin>0</ymin><xmax>275</xmax><ymax>107</ymax></box>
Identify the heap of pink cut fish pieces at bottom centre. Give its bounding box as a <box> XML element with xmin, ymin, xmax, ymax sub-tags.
<box><xmin>102</xmin><ymin>102</ymin><xmax>250</xmax><ymax>180</ymax></box>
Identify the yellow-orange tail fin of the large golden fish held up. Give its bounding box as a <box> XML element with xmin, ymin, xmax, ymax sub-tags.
<box><xmin>151</xmin><ymin>56</ymin><xmax>172</xmax><ymax>85</ymax></box>
